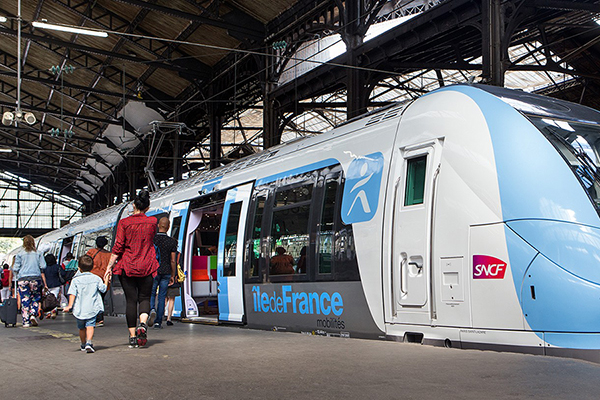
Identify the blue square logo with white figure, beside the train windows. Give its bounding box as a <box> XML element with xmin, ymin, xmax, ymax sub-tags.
<box><xmin>342</xmin><ymin>152</ymin><xmax>383</xmax><ymax>224</ymax></box>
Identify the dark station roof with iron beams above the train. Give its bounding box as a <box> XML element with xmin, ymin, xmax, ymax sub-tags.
<box><xmin>0</xmin><ymin>0</ymin><xmax>600</xmax><ymax>213</ymax></box>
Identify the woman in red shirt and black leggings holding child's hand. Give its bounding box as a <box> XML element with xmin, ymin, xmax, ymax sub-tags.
<box><xmin>107</xmin><ymin>190</ymin><xmax>158</xmax><ymax>348</ymax></box>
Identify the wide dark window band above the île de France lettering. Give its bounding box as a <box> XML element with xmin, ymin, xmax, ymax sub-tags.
<box><xmin>245</xmin><ymin>165</ymin><xmax>359</xmax><ymax>282</ymax></box>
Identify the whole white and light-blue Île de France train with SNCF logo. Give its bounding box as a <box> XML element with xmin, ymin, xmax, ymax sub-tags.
<box><xmin>34</xmin><ymin>85</ymin><xmax>600</xmax><ymax>362</ymax></box>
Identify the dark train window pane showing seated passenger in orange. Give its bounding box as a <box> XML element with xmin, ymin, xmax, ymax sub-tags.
<box><xmin>269</xmin><ymin>182</ymin><xmax>313</xmax><ymax>275</ymax></box>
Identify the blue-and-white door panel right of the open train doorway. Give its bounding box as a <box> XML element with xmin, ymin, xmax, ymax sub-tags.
<box><xmin>217</xmin><ymin>183</ymin><xmax>252</xmax><ymax>322</ymax></box>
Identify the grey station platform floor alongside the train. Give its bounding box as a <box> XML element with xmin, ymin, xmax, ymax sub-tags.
<box><xmin>0</xmin><ymin>315</ymin><xmax>600</xmax><ymax>400</ymax></box>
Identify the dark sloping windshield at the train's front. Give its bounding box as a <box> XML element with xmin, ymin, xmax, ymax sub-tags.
<box><xmin>529</xmin><ymin>116</ymin><xmax>600</xmax><ymax>209</ymax></box>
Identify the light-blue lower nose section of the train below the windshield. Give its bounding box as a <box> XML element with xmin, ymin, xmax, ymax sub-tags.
<box><xmin>507</xmin><ymin>220</ymin><xmax>600</xmax><ymax>332</ymax></box>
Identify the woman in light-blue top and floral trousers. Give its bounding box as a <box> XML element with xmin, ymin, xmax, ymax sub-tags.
<box><xmin>13</xmin><ymin>235</ymin><xmax>48</xmax><ymax>327</ymax></box>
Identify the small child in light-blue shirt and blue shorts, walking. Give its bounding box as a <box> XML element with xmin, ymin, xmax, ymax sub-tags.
<box><xmin>64</xmin><ymin>256</ymin><xmax>111</xmax><ymax>353</ymax></box>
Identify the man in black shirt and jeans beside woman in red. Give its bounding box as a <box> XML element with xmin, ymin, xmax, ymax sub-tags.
<box><xmin>148</xmin><ymin>217</ymin><xmax>177</xmax><ymax>329</ymax></box>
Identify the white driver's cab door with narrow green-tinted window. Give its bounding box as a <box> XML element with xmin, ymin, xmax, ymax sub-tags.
<box><xmin>386</xmin><ymin>141</ymin><xmax>441</xmax><ymax>324</ymax></box>
